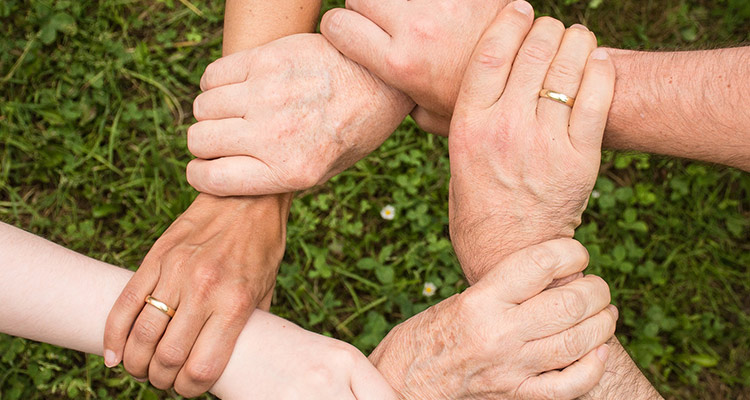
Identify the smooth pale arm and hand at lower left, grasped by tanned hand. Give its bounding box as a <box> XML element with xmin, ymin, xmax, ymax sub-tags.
<box><xmin>0</xmin><ymin>223</ymin><xmax>395</xmax><ymax>400</ymax></box>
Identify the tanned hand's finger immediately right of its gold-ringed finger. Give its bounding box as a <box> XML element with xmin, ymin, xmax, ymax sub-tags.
<box><xmin>148</xmin><ymin>303</ymin><xmax>208</xmax><ymax>390</ymax></box>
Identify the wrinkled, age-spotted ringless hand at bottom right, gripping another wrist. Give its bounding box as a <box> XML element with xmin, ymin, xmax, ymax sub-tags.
<box><xmin>370</xmin><ymin>239</ymin><xmax>618</xmax><ymax>400</ymax></box>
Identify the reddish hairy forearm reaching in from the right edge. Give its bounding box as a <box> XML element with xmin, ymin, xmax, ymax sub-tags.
<box><xmin>604</xmin><ymin>47</ymin><xmax>750</xmax><ymax>170</ymax></box>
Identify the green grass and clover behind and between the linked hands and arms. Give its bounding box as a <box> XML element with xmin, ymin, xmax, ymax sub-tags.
<box><xmin>0</xmin><ymin>0</ymin><xmax>750</xmax><ymax>399</ymax></box>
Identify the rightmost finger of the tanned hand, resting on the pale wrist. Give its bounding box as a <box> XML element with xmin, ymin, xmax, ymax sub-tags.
<box><xmin>174</xmin><ymin>316</ymin><xmax>245</xmax><ymax>397</ymax></box>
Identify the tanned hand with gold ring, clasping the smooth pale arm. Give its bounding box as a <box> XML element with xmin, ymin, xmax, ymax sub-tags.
<box><xmin>104</xmin><ymin>195</ymin><xmax>291</xmax><ymax>397</ymax></box>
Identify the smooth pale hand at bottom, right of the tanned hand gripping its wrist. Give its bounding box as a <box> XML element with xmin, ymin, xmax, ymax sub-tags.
<box><xmin>211</xmin><ymin>311</ymin><xmax>396</xmax><ymax>400</ymax></box>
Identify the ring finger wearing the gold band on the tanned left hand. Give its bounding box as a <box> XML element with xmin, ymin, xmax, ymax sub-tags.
<box><xmin>122</xmin><ymin>280</ymin><xmax>180</xmax><ymax>379</ymax></box>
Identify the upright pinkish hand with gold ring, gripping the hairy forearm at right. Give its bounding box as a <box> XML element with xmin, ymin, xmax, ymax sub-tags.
<box><xmin>449</xmin><ymin>1</ymin><xmax>615</xmax><ymax>282</ymax></box>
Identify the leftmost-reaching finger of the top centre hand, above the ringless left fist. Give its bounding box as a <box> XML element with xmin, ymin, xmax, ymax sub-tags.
<box><xmin>320</xmin><ymin>8</ymin><xmax>394</xmax><ymax>82</ymax></box>
